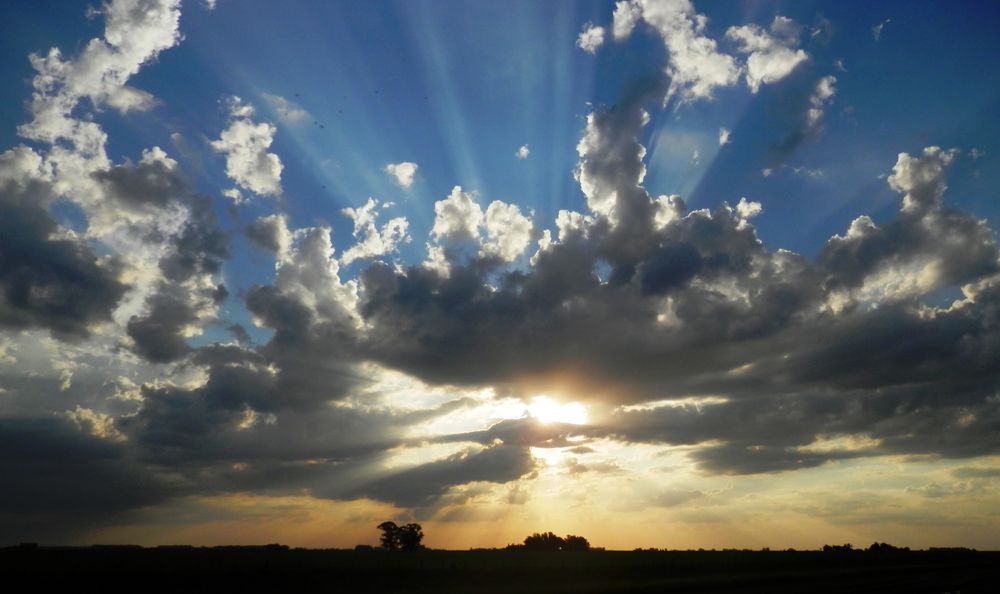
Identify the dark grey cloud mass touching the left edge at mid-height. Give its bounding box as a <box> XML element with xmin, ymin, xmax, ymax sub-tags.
<box><xmin>0</xmin><ymin>162</ymin><xmax>127</xmax><ymax>338</ymax></box>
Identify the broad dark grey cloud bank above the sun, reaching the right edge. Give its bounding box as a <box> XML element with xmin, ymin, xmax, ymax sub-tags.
<box><xmin>350</xmin><ymin>86</ymin><xmax>1000</xmax><ymax>474</ymax></box>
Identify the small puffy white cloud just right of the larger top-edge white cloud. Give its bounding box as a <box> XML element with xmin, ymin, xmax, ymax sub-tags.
<box><xmin>726</xmin><ymin>15</ymin><xmax>809</xmax><ymax>93</ymax></box>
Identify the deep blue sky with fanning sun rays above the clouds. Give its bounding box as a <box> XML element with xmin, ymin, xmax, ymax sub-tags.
<box><xmin>0</xmin><ymin>1</ymin><xmax>1000</xmax><ymax>254</ymax></box>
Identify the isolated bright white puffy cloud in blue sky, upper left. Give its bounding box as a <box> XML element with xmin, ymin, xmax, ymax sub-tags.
<box><xmin>211</xmin><ymin>97</ymin><xmax>283</xmax><ymax>196</ymax></box>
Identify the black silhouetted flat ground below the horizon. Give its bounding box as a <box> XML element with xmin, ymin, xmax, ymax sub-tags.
<box><xmin>0</xmin><ymin>547</ymin><xmax>1000</xmax><ymax>593</ymax></box>
